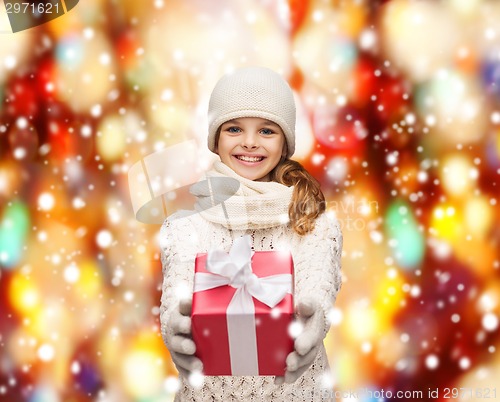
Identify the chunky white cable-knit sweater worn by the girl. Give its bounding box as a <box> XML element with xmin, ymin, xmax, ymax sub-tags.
<box><xmin>160</xmin><ymin>214</ymin><xmax>342</xmax><ymax>402</ymax></box>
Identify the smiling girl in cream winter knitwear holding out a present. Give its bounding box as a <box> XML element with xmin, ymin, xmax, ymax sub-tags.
<box><xmin>160</xmin><ymin>67</ymin><xmax>342</xmax><ymax>401</ymax></box>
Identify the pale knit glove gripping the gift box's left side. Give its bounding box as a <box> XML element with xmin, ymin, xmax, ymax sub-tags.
<box><xmin>167</xmin><ymin>299</ymin><xmax>203</xmax><ymax>378</ymax></box>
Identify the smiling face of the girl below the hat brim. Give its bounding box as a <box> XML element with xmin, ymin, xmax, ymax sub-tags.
<box><xmin>217</xmin><ymin>117</ymin><xmax>286</xmax><ymax>181</ymax></box>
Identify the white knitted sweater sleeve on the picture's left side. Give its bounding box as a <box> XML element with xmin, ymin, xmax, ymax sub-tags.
<box><xmin>160</xmin><ymin>215</ymin><xmax>197</xmax><ymax>348</ymax></box>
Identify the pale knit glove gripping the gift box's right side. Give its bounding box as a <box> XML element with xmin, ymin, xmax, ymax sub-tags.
<box><xmin>274</xmin><ymin>299</ymin><xmax>325</xmax><ymax>385</ymax></box>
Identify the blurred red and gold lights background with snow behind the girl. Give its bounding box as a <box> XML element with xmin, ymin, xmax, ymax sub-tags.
<box><xmin>0</xmin><ymin>0</ymin><xmax>500</xmax><ymax>402</ymax></box>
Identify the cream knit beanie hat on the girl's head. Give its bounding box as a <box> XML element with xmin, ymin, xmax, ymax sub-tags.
<box><xmin>208</xmin><ymin>67</ymin><xmax>295</xmax><ymax>157</ymax></box>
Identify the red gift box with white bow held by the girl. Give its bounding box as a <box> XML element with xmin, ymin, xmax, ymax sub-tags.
<box><xmin>191</xmin><ymin>238</ymin><xmax>294</xmax><ymax>376</ymax></box>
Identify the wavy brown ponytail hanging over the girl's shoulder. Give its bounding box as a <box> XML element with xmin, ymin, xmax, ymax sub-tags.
<box><xmin>270</xmin><ymin>159</ymin><xmax>325</xmax><ymax>235</ymax></box>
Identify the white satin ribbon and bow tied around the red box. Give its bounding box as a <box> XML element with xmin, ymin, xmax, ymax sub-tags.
<box><xmin>194</xmin><ymin>235</ymin><xmax>292</xmax><ymax>375</ymax></box>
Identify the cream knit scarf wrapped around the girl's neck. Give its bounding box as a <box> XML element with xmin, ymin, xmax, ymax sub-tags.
<box><xmin>190</xmin><ymin>161</ymin><xmax>293</xmax><ymax>230</ymax></box>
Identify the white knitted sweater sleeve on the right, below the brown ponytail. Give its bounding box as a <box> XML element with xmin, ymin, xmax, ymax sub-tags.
<box><xmin>294</xmin><ymin>213</ymin><xmax>343</xmax><ymax>336</ymax></box>
